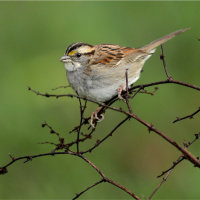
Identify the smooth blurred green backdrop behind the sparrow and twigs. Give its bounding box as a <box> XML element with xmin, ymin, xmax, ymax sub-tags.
<box><xmin>0</xmin><ymin>2</ymin><xmax>200</xmax><ymax>199</ymax></box>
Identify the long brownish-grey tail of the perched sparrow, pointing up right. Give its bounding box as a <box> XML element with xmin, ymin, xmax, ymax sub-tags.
<box><xmin>139</xmin><ymin>28</ymin><xmax>190</xmax><ymax>52</ymax></box>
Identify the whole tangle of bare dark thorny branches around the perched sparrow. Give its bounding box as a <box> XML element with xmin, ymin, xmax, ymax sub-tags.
<box><xmin>0</xmin><ymin>45</ymin><xmax>200</xmax><ymax>200</ymax></box>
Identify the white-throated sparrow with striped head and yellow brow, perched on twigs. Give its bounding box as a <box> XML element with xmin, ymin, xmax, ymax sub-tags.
<box><xmin>60</xmin><ymin>28</ymin><xmax>190</xmax><ymax>127</ymax></box>
